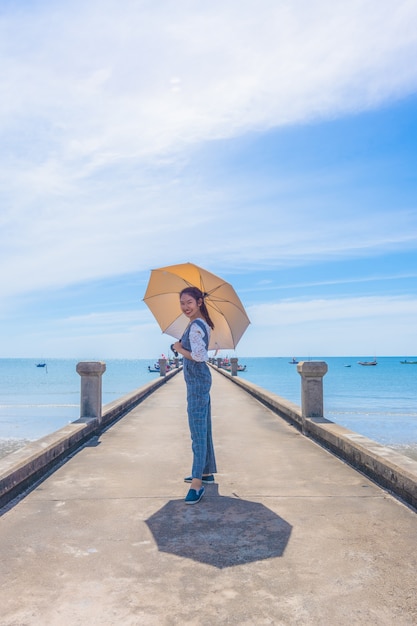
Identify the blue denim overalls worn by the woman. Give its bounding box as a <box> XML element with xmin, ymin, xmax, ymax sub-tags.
<box><xmin>181</xmin><ymin>319</ymin><xmax>217</xmax><ymax>479</ymax></box>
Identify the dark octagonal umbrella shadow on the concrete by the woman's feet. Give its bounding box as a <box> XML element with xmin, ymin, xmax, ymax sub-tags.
<box><xmin>146</xmin><ymin>485</ymin><xmax>292</xmax><ymax>569</ymax></box>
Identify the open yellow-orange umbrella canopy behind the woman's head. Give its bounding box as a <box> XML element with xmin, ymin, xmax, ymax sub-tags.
<box><xmin>143</xmin><ymin>263</ymin><xmax>250</xmax><ymax>350</ymax></box>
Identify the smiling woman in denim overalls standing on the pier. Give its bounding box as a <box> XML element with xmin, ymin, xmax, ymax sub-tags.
<box><xmin>172</xmin><ymin>287</ymin><xmax>217</xmax><ymax>504</ymax></box>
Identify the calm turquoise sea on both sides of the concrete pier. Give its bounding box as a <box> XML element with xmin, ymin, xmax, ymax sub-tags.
<box><xmin>0</xmin><ymin>354</ymin><xmax>417</xmax><ymax>460</ymax></box>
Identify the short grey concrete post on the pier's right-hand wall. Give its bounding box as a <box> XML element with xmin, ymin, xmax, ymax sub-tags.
<box><xmin>297</xmin><ymin>361</ymin><xmax>328</xmax><ymax>434</ymax></box>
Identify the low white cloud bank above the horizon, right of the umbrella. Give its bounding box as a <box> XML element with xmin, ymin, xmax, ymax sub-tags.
<box><xmin>234</xmin><ymin>296</ymin><xmax>417</xmax><ymax>357</ymax></box>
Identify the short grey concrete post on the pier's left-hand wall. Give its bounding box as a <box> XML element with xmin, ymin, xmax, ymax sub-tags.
<box><xmin>76</xmin><ymin>361</ymin><xmax>106</xmax><ymax>423</ymax></box>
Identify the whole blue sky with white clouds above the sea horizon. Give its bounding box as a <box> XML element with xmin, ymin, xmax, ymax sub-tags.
<box><xmin>0</xmin><ymin>0</ymin><xmax>417</xmax><ymax>359</ymax></box>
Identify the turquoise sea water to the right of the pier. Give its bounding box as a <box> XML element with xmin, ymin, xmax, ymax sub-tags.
<box><xmin>234</xmin><ymin>357</ymin><xmax>417</xmax><ymax>446</ymax></box>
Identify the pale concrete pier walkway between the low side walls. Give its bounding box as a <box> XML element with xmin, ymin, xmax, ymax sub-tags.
<box><xmin>0</xmin><ymin>372</ymin><xmax>417</xmax><ymax>626</ymax></box>
